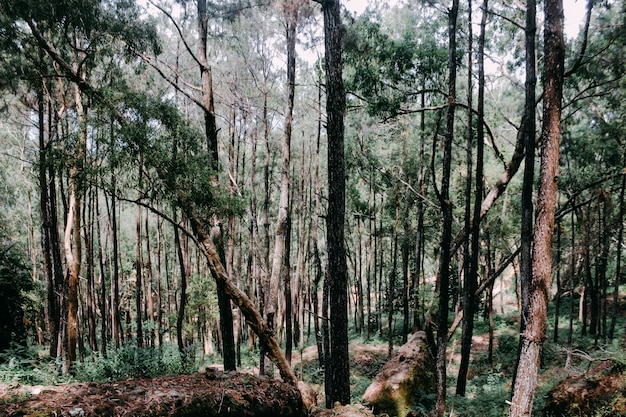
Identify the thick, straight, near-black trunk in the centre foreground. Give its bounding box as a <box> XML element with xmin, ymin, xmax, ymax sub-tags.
<box><xmin>322</xmin><ymin>0</ymin><xmax>350</xmax><ymax>408</ymax></box>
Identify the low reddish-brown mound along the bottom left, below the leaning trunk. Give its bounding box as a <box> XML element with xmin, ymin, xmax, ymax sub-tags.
<box><xmin>0</xmin><ymin>370</ymin><xmax>306</xmax><ymax>417</ymax></box>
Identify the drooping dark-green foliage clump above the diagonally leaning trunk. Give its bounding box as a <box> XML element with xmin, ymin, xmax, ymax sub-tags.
<box><xmin>111</xmin><ymin>90</ymin><xmax>246</xmax><ymax>219</ymax></box>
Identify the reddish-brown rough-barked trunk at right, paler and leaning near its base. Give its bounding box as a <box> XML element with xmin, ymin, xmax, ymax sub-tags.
<box><xmin>510</xmin><ymin>0</ymin><xmax>565</xmax><ymax>417</ymax></box>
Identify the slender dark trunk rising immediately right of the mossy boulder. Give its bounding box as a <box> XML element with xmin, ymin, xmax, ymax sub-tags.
<box><xmin>433</xmin><ymin>0</ymin><xmax>459</xmax><ymax>417</ymax></box>
